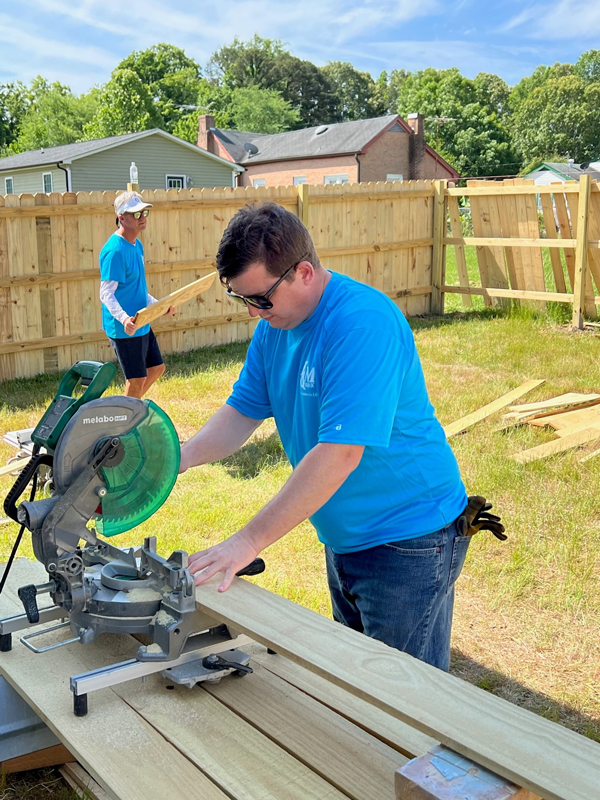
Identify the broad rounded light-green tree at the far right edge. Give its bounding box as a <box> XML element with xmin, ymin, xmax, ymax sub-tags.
<box><xmin>513</xmin><ymin>74</ymin><xmax>600</xmax><ymax>162</ymax></box>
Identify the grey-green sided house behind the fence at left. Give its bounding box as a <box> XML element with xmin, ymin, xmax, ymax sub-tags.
<box><xmin>0</xmin><ymin>128</ymin><xmax>244</xmax><ymax>194</ymax></box>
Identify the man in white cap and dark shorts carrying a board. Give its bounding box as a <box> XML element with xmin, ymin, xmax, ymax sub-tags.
<box><xmin>100</xmin><ymin>192</ymin><xmax>174</xmax><ymax>399</ymax></box>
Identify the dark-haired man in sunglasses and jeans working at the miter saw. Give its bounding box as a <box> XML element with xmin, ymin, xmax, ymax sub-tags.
<box><xmin>180</xmin><ymin>203</ymin><xmax>497</xmax><ymax>670</ymax></box>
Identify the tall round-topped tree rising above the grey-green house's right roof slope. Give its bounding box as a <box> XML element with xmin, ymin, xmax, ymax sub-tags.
<box><xmin>117</xmin><ymin>44</ymin><xmax>202</xmax><ymax>132</ymax></box>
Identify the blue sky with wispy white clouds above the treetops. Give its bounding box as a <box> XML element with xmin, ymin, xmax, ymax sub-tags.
<box><xmin>0</xmin><ymin>0</ymin><xmax>600</xmax><ymax>92</ymax></box>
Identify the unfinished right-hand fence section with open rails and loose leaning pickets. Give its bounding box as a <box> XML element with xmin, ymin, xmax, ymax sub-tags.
<box><xmin>442</xmin><ymin>175</ymin><xmax>600</xmax><ymax>328</ymax></box>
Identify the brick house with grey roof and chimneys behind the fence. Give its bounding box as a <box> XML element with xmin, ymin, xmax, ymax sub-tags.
<box><xmin>197</xmin><ymin>114</ymin><xmax>459</xmax><ymax>186</ymax></box>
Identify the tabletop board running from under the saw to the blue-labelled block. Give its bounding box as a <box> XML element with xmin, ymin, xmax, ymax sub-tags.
<box><xmin>204</xmin><ymin>648</ymin><xmax>408</xmax><ymax>800</ymax></box>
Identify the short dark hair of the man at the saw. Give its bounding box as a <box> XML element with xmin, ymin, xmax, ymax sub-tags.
<box><xmin>217</xmin><ymin>203</ymin><xmax>321</xmax><ymax>283</ymax></box>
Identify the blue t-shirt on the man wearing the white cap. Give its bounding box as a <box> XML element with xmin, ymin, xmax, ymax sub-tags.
<box><xmin>100</xmin><ymin>233</ymin><xmax>150</xmax><ymax>339</ymax></box>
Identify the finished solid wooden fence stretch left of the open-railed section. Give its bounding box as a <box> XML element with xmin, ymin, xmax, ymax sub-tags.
<box><xmin>0</xmin><ymin>181</ymin><xmax>434</xmax><ymax>380</ymax></box>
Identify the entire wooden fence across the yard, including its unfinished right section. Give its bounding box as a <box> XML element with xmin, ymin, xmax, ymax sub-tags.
<box><xmin>0</xmin><ymin>175</ymin><xmax>600</xmax><ymax>380</ymax></box>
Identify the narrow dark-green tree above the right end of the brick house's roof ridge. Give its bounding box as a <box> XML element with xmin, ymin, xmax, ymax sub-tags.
<box><xmin>321</xmin><ymin>61</ymin><xmax>387</xmax><ymax>122</ymax></box>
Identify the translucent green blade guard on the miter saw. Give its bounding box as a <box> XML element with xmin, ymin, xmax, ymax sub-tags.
<box><xmin>96</xmin><ymin>400</ymin><xmax>181</xmax><ymax>536</ymax></box>
